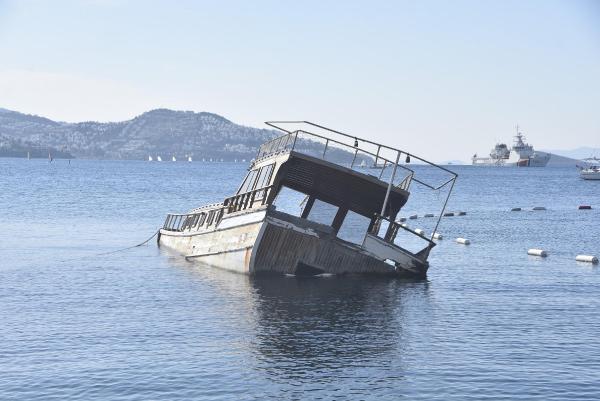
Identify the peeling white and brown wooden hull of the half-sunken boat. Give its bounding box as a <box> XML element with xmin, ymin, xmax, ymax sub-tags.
<box><xmin>159</xmin><ymin>210</ymin><xmax>428</xmax><ymax>278</ymax></box>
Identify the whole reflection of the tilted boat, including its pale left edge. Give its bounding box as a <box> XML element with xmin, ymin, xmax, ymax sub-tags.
<box><xmin>168</xmin><ymin>258</ymin><xmax>431</xmax><ymax>368</ymax></box>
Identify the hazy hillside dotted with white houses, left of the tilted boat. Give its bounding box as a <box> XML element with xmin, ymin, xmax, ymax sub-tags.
<box><xmin>0</xmin><ymin>108</ymin><xmax>278</xmax><ymax>160</ymax></box>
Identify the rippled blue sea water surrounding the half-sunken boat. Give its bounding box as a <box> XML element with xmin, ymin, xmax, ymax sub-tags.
<box><xmin>0</xmin><ymin>159</ymin><xmax>600</xmax><ymax>400</ymax></box>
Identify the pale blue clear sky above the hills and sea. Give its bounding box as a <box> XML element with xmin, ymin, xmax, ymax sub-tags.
<box><xmin>0</xmin><ymin>0</ymin><xmax>600</xmax><ymax>161</ymax></box>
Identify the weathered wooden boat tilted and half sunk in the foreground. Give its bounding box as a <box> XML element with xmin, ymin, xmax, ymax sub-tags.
<box><xmin>158</xmin><ymin>122</ymin><xmax>457</xmax><ymax>278</ymax></box>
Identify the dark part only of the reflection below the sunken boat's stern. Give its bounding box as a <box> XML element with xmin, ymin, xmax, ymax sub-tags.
<box><xmin>250</xmin><ymin>277</ymin><xmax>420</xmax><ymax>362</ymax></box>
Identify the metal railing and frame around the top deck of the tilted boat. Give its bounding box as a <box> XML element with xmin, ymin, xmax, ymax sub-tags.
<box><xmin>257</xmin><ymin>121</ymin><xmax>458</xmax><ymax>239</ymax></box>
